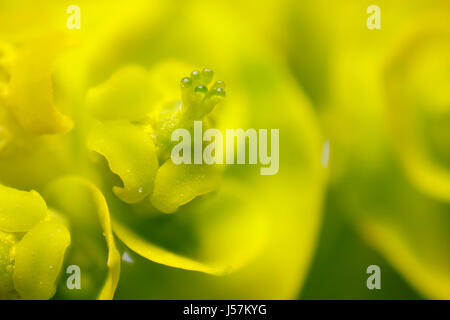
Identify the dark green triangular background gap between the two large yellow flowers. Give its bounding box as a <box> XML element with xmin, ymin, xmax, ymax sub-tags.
<box><xmin>299</xmin><ymin>190</ymin><xmax>424</xmax><ymax>299</ymax></box>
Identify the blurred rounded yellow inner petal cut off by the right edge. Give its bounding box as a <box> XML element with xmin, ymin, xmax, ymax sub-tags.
<box><xmin>384</xmin><ymin>22</ymin><xmax>450</xmax><ymax>202</ymax></box>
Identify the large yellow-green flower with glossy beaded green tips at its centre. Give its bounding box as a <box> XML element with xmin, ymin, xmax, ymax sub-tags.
<box><xmin>0</xmin><ymin>1</ymin><xmax>326</xmax><ymax>299</ymax></box>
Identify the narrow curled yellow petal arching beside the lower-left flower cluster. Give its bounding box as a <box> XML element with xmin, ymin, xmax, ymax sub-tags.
<box><xmin>45</xmin><ymin>177</ymin><xmax>120</xmax><ymax>300</ymax></box>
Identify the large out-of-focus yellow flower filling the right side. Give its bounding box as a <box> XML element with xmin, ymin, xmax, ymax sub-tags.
<box><xmin>291</xmin><ymin>1</ymin><xmax>450</xmax><ymax>299</ymax></box>
